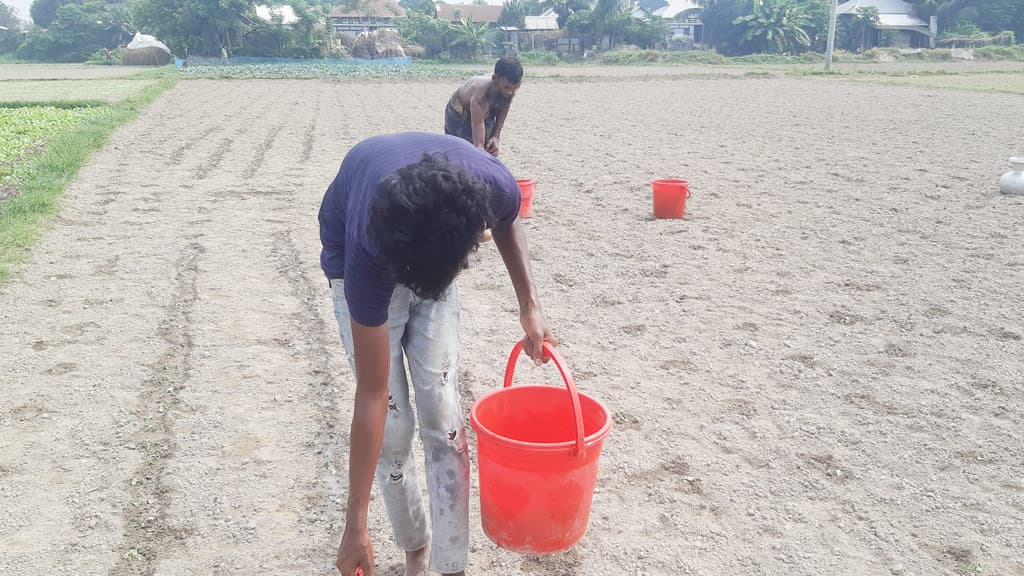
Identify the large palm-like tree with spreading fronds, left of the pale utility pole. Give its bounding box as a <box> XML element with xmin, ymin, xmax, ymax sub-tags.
<box><xmin>732</xmin><ymin>0</ymin><xmax>811</xmax><ymax>53</ymax></box>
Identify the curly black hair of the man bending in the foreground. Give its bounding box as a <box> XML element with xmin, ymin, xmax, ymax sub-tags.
<box><xmin>367</xmin><ymin>154</ymin><xmax>493</xmax><ymax>300</ymax></box>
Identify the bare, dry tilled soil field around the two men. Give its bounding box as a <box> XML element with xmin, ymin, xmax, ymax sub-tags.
<box><xmin>0</xmin><ymin>73</ymin><xmax>1024</xmax><ymax>576</ymax></box>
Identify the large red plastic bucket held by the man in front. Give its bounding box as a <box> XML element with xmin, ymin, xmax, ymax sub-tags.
<box><xmin>470</xmin><ymin>341</ymin><xmax>611</xmax><ymax>554</ymax></box>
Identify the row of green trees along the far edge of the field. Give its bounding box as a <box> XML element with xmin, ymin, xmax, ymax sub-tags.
<box><xmin>0</xmin><ymin>0</ymin><xmax>1024</xmax><ymax>61</ymax></box>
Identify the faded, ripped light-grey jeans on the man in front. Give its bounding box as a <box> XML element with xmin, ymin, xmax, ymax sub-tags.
<box><xmin>331</xmin><ymin>280</ymin><xmax>469</xmax><ymax>574</ymax></box>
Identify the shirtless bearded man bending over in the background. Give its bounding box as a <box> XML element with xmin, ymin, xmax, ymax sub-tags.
<box><xmin>444</xmin><ymin>56</ymin><xmax>522</xmax><ymax>156</ymax></box>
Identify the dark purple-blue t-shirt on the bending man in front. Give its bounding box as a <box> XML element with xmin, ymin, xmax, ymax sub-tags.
<box><xmin>319</xmin><ymin>132</ymin><xmax>519</xmax><ymax>326</ymax></box>
